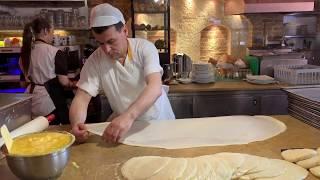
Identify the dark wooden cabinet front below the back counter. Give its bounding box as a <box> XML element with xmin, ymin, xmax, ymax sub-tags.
<box><xmin>169</xmin><ymin>90</ymin><xmax>288</xmax><ymax>118</ymax></box>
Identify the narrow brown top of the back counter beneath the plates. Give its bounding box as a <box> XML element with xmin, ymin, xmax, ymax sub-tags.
<box><xmin>169</xmin><ymin>81</ymin><xmax>287</xmax><ymax>93</ymax></box>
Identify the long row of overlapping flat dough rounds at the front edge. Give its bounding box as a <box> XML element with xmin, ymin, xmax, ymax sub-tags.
<box><xmin>121</xmin><ymin>153</ymin><xmax>308</xmax><ymax>180</ymax></box>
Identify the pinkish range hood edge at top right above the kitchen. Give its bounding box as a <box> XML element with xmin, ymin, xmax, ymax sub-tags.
<box><xmin>225</xmin><ymin>0</ymin><xmax>315</xmax><ymax>15</ymax></box>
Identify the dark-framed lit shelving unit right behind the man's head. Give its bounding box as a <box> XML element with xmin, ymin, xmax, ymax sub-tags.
<box><xmin>131</xmin><ymin>0</ymin><xmax>170</xmax><ymax>65</ymax></box>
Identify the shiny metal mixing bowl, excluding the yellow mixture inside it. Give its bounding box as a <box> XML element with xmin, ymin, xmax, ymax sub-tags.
<box><xmin>4</xmin><ymin>132</ymin><xmax>75</xmax><ymax>179</ymax></box>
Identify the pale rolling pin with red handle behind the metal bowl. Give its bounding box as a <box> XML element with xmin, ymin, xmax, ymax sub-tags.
<box><xmin>0</xmin><ymin>115</ymin><xmax>50</xmax><ymax>147</ymax></box>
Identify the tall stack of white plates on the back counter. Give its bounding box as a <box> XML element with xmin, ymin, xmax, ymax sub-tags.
<box><xmin>192</xmin><ymin>63</ymin><xmax>215</xmax><ymax>83</ymax></box>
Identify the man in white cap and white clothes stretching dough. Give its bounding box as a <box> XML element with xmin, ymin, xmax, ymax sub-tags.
<box><xmin>69</xmin><ymin>3</ymin><xmax>175</xmax><ymax>143</ymax></box>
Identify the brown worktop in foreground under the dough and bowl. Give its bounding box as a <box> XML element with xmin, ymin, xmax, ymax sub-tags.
<box><xmin>0</xmin><ymin>115</ymin><xmax>320</xmax><ymax>180</ymax></box>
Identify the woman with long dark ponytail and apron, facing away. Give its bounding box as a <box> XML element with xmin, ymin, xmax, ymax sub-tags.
<box><xmin>19</xmin><ymin>18</ymin><xmax>75</xmax><ymax>124</ymax></box>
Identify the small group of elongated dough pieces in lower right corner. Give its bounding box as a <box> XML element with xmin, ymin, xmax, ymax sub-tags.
<box><xmin>281</xmin><ymin>147</ymin><xmax>320</xmax><ymax>177</ymax></box>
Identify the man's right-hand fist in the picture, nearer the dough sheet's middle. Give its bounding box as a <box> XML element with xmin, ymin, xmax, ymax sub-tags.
<box><xmin>103</xmin><ymin>114</ymin><xmax>134</xmax><ymax>143</ymax></box>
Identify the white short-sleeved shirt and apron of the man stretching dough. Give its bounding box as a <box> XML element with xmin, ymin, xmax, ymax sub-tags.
<box><xmin>77</xmin><ymin>38</ymin><xmax>175</xmax><ymax>121</ymax></box>
